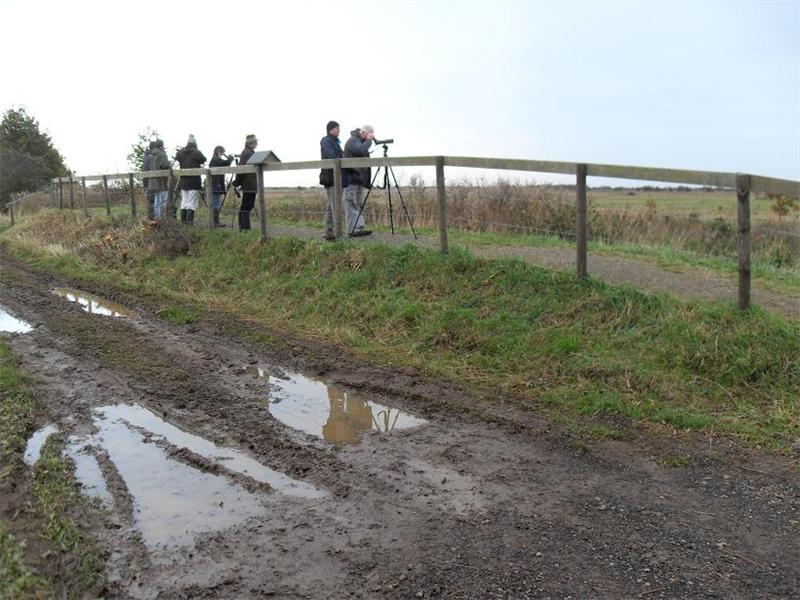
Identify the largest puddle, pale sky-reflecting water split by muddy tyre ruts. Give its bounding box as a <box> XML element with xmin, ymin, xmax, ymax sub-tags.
<box><xmin>26</xmin><ymin>405</ymin><xmax>326</xmax><ymax>550</ymax></box>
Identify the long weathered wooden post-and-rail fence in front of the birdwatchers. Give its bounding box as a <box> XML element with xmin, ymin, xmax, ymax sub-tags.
<box><xmin>7</xmin><ymin>156</ymin><xmax>800</xmax><ymax>309</ymax></box>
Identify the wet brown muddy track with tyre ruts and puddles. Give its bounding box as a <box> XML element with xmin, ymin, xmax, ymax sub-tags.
<box><xmin>0</xmin><ymin>255</ymin><xmax>800</xmax><ymax>599</ymax></box>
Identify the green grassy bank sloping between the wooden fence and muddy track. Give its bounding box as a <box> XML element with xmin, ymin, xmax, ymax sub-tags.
<box><xmin>0</xmin><ymin>213</ymin><xmax>800</xmax><ymax>451</ymax></box>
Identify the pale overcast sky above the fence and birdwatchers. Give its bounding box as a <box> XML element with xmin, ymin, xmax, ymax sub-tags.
<box><xmin>0</xmin><ymin>0</ymin><xmax>800</xmax><ymax>185</ymax></box>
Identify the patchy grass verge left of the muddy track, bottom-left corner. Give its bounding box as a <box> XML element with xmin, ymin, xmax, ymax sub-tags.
<box><xmin>0</xmin><ymin>341</ymin><xmax>102</xmax><ymax>599</ymax></box>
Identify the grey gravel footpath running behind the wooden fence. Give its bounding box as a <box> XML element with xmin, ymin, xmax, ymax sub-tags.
<box><xmin>269</xmin><ymin>225</ymin><xmax>800</xmax><ymax>319</ymax></box>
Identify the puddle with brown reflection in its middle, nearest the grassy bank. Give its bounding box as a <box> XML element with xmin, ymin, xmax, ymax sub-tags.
<box><xmin>260</xmin><ymin>367</ymin><xmax>427</xmax><ymax>444</ymax></box>
